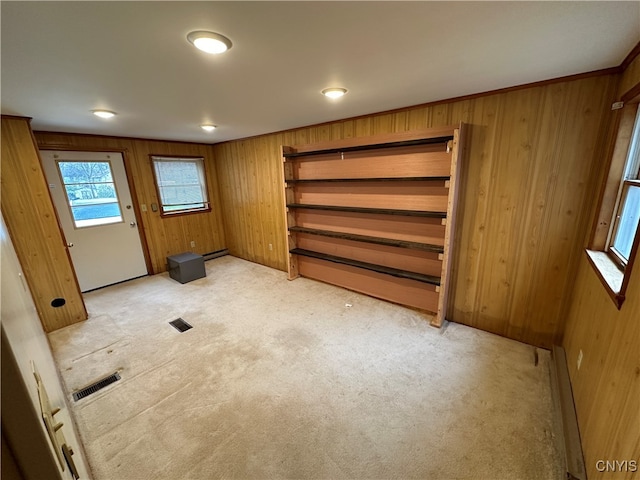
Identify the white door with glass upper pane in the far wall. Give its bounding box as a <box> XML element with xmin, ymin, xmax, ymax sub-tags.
<box><xmin>40</xmin><ymin>150</ymin><xmax>148</xmax><ymax>292</ymax></box>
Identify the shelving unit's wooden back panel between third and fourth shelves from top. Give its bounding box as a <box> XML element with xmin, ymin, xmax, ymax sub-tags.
<box><xmin>295</xmin><ymin>209</ymin><xmax>445</xmax><ymax>246</ymax></box>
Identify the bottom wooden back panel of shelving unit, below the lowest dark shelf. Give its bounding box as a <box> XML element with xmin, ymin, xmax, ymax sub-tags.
<box><xmin>298</xmin><ymin>257</ymin><xmax>439</xmax><ymax>313</ymax></box>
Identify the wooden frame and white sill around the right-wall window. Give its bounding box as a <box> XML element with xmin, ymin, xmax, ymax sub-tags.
<box><xmin>586</xmin><ymin>95</ymin><xmax>640</xmax><ymax>309</ymax></box>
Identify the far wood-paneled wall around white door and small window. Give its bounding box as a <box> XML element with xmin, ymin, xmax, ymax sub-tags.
<box><xmin>35</xmin><ymin>132</ymin><xmax>226</xmax><ymax>273</ymax></box>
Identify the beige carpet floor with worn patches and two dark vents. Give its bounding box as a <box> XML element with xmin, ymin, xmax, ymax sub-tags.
<box><xmin>49</xmin><ymin>256</ymin><xmax>563</xmax><ymax>480</ymax></box>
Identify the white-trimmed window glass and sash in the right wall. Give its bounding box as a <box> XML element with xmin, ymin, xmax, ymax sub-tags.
<box><xmin>608</xmin><ymin>105</ymin><xmax>640</xmax><ymax>270</ymax></box>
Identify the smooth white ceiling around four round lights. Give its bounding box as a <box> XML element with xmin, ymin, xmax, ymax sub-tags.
<box><xmin>1</xmin><ymin>1</ymin><xmax>640</xmax><ymax>143</ymax></box>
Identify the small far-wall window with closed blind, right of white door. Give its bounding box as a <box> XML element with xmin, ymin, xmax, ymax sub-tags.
<box><xmin>151</xmin><ymin>155</ymin><xmax>211</xmax><ymax>215</ymax></box>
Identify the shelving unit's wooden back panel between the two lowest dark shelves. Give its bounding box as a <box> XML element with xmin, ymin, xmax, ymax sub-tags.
<box><xmin>297</xmin><ymin>233</ymin><xmax>442</xmax><ymax>277</ymax></box>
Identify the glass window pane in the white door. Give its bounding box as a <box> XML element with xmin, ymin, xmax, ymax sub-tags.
<box><xmin>58</xmin><ymin>162</ymin><xmax>122</xmax><ymax>228</ymax></box>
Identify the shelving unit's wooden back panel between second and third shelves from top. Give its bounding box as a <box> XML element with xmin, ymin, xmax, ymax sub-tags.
<box><xmin>295</xmin><ymin>181</ymin><xmax>449</xmax><ymax>212</ymax></box>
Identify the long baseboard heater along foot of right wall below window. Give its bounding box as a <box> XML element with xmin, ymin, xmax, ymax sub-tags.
<box><xmin>550</xmin><ymin>345</ymin><xmax>587</xmax><ymax>480</ymax></box>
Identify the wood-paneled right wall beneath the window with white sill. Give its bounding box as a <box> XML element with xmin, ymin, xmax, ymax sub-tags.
<box><xmin>563</xmin><ymin>50</ymin><xmax>640</xmax><ymax>480</ymax></box>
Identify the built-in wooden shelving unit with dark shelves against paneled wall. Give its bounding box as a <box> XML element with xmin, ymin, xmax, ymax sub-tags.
<box><xmin>282</xmin><ymin>125</ymin><xmax>463</xmax><ymax>326</ymax></box>
